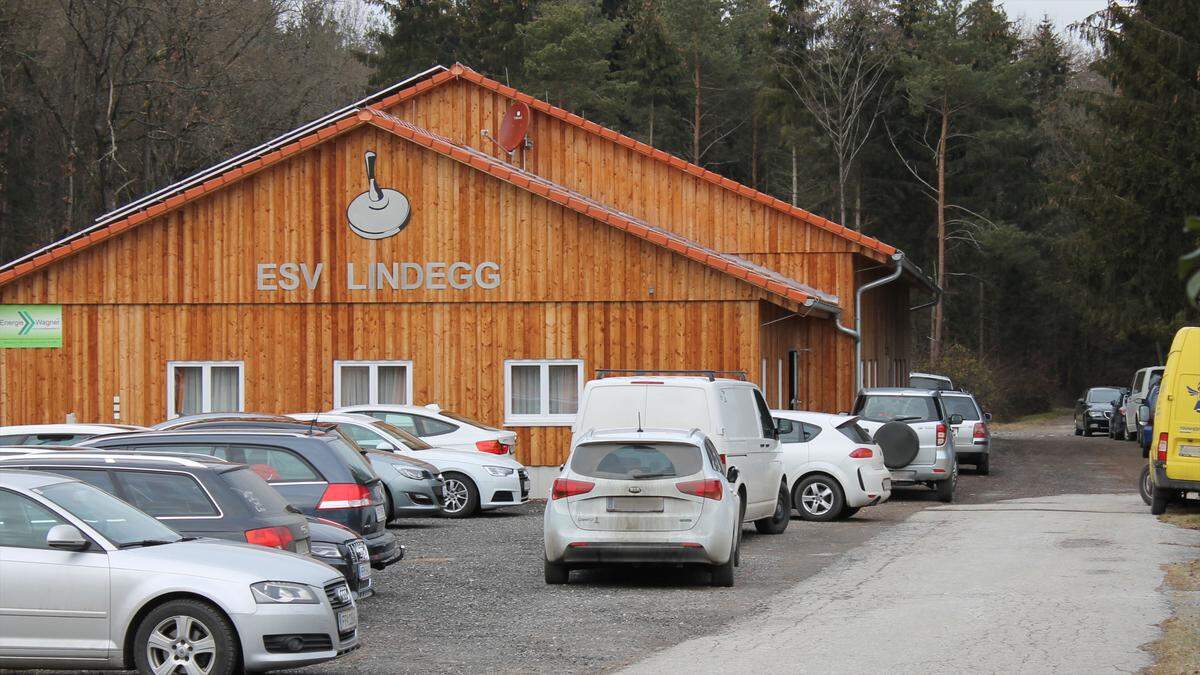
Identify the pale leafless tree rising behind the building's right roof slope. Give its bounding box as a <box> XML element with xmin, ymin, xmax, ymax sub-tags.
<box><xmin>779</xmin><ymin>0</ymin><xmax>892</xmax><ymax>226</ymax></box>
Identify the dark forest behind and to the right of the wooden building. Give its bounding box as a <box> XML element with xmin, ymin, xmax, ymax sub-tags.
<box><xmin>0</xmin><ymin>0</ymin><xmax>1200</xmax><ymax>416</ymax></box>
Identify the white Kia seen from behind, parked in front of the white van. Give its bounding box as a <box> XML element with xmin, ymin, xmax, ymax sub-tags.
<box><xmin>542</xmin><ymin>429</ymin><xmax>742</xmax><ymax>586</ymax></box>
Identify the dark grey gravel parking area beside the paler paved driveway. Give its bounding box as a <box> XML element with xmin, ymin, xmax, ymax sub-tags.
<box><xmin>295</xmin><ymin>413</ymin><xmax>1148</xmax><ymax>673</ymax></box>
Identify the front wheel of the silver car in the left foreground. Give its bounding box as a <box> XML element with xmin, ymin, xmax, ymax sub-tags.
<box><xmin>133</xmin><ymin>599</ymin><xmax>241</xmax><ymax>675</ymax></box>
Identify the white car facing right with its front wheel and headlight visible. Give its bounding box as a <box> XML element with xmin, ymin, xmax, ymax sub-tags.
<box><xmin>290</xmin><ymin>412</ymin><xmax>529</xmax><ymax>518</ymax></box>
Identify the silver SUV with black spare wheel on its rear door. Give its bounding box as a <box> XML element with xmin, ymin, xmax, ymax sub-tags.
<box><xmin>854</xmin><ymin>387</ymin><xmax>962</xmax><ymax>502</ymax></box>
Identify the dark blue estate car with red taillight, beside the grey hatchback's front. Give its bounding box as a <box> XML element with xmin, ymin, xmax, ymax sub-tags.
<box><xmin>82</xmin><ymin>429</ymin><xmax>403</xmax><ymax>569</ymax></box>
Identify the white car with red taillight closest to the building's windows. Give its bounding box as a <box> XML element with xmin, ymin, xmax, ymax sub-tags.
<box><xmin>330</xmin><ymin>404</ymin><xmax>517</xmax><ymax>455</ymax></box>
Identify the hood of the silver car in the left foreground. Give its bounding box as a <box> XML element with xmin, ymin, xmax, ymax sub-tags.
<box><xmin>109</xmin><ymin>538</ymin><xmax>341</xmax><ymax>587</ymax></box>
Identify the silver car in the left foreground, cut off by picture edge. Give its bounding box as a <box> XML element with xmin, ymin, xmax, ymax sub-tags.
<box><xmin>0</xmin><ymin>470</ymin><xmax>359</xmax><ymax>675</ymax></box>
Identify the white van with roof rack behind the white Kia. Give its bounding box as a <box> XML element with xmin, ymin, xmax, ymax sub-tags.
<box><xmin>571</xmin><ymin>371</ymin><xmax>792</xmax><ymax>534</ymax></box>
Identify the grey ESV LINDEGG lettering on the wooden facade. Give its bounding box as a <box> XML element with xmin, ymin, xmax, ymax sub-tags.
<box><xmin>254</xmin><ymin>261</ymin><xmax>500</xmax><ymax>291</ymax></box>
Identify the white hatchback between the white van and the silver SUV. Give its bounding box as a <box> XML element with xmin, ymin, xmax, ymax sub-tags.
<box><xmin>770</xmin><ymin>410</ymin><xmax>892</xmax><ymax>521</ymax></box>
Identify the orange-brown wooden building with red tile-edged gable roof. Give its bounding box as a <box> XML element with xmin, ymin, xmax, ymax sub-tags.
<box><xmin>0</xmin><ymin>65</ymin><xmax>936</xmax><ymax>466</ymax></box>
